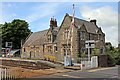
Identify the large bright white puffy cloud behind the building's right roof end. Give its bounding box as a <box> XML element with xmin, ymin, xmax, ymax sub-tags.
<box><xmin>80</xmin><ymin>6</ymin><xmax>118</xmax><ymax>46</ymax></box>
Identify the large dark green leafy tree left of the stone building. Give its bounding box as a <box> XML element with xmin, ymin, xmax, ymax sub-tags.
<box><xmin>2</xmin><ymin>19</ymin><xmax>31</xmax><ymax>49</ymax></box>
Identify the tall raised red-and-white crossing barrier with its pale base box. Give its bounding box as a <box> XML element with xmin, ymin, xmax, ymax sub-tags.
<box><xmin>64</xmin><ymin>4</ymin><xmax>75</xmax><ymax>66</ymax></box>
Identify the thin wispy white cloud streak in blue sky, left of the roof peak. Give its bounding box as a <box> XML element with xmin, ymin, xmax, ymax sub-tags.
<box><xmin>25</xmin><ymin>3</ymin><xmax>59</xmax><ymax>23</ymax></box>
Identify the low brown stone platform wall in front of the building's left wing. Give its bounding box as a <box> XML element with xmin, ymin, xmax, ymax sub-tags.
<box><xmin>0</xmin><ymin>59</ymin><xmax>55</xmax><ymax>69</ymax></box>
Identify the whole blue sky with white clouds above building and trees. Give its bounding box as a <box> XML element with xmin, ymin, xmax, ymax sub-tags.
<box><xmin>0</xmin><ymin>2</ymin><xmax>118</xmax><ymax>46</ymax></box>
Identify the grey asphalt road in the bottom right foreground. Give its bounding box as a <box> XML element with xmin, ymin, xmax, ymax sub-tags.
<box><xmin>39</xmin><ymin>67</ymin><xmax>118</xmax><ymax>78</ymax></box>
